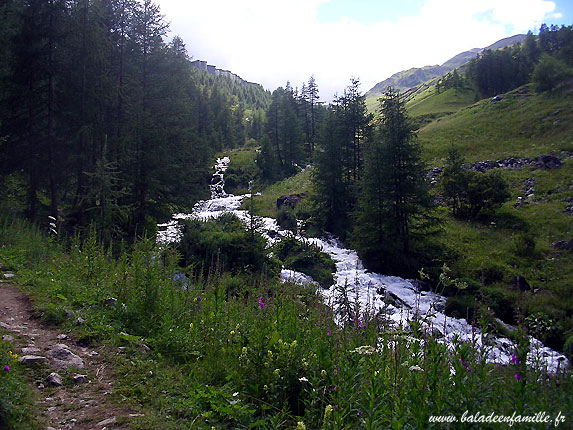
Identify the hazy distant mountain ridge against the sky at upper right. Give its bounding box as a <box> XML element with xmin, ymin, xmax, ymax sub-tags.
<box><xmin>365</xmin><ymin>34</ymin><xmax>526</xmax><ymax>97</ymax></box>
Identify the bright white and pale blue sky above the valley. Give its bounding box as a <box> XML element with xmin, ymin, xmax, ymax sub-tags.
<box><xmin>155</xmin><ymin>0</ymin><xmax>573</xmax><ymax>102</ymax></box>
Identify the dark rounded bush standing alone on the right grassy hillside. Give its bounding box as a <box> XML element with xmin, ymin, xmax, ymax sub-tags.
<box><xmin>440</xmin><ymin>148</ymin><xmax>510</xmax><ymax>219</ymax></box>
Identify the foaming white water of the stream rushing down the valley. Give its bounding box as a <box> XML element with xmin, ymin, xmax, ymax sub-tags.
<box><xmin>157</xmin><ymin>157</ymin><xmax>568</xmax><ymax>372</ymax></box>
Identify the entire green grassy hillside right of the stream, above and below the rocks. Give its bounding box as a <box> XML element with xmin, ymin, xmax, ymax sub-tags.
<box><xmin>408</xmin><ymin>81</ymin><xmax>573</xmax><ymax>348</ymax></box>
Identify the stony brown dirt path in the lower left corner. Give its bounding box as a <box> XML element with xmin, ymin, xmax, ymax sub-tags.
<box><xmin>0</xmin><ymin>283</ymin><xmax>137</xmax><ymax>430</ymax></box>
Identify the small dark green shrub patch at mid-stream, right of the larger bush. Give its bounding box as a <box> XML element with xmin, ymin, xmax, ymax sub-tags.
<box><xmin>275</xmin><ymin>237</ymin><xmax>336</xmax><ymax>288</ymax></box>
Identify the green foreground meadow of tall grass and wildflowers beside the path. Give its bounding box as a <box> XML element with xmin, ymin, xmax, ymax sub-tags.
<box><xmin>0</xmin><ymin>215</ymin><xmax>573</xmax><ymax>430</ymax></box>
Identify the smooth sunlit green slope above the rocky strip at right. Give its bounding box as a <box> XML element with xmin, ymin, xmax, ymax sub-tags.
<box><xmin>418</xmin><ymin>85</ymin><xmax>573</xmax><ymax>166</ymax></box>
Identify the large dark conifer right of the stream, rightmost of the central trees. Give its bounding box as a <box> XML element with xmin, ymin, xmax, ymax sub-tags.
<box><xmin>355</xmin><ymin>89</ymin><xmax>432</xmax><ymax>273</ymax></box>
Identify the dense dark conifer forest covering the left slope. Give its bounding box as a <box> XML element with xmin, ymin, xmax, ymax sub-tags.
<box><xmin>0</xmin><ymin>0</ymin><xmax>270</xmax><ymax>241</ymax></box>
